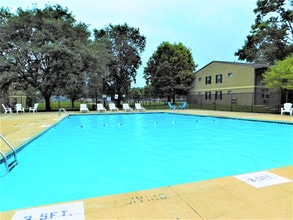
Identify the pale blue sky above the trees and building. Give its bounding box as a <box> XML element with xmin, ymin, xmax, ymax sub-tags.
<box><xmin>0</xmin><ymin>0</ymin><xmax>256</xmax><ymax>87</ymax></box>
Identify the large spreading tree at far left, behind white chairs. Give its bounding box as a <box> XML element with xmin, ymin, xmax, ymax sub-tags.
<box><xmin>0</xmin><ymin>5</ymin><xmax>96</xmax><ymax>110</ymax></box>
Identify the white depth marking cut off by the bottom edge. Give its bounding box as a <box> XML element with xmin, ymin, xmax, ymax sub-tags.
<box><xmin>12</xmin><ymin>201</ymin><xmax>85</xmax><ymax>220</ymax></box>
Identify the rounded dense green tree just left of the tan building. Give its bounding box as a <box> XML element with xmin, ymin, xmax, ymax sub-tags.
<box><xmin>144</xmin><ymin>42</ymin><xmax>196</xmax><ymax>103</ymax></box>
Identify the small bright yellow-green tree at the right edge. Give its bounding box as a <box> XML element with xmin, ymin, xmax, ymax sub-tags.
<box><xmin>263</xmin><ymin>55</ymin><xmax>293</xmax><ymax>101</ymax></box>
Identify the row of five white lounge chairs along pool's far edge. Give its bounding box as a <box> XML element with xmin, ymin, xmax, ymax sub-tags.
<box><xmin>80</xmin><ymin>103</ymin><xmax>146</xmax><ymax>112</ymax></box>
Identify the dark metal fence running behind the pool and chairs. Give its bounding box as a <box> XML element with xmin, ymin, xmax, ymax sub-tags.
<box><xmin>0</xmin><ymin>91</ymin><xmax>293</xmax><ymax>113</ymax></box>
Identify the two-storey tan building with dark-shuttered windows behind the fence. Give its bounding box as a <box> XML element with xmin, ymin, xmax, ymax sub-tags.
<box><xmin>189</xmin><ymin>61</ymin><xmax>278</xmax><ymax>105</ymax></box>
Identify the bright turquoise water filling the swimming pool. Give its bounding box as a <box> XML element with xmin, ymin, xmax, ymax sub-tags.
<box><xmin>0</xmin><ymin>113</ymin><xmax>293</xmax><ymax>211</ymax></box>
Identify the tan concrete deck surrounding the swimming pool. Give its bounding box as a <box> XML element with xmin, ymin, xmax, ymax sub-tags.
<box><xmin>0</xmin><ymin>110</ymin><xmax>293</xmax><ymax>220</ymax></box>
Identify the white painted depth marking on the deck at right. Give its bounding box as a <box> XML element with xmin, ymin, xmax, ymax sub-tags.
<box><xmin>234</xmin><ymin>171</ymin><xmax>292</xmax><ymax>188</ymax></box>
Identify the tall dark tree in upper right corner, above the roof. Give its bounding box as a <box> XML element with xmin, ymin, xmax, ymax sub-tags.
<box><xmin>235</xmin><ymin>0</ymin><xmax>293</xmax><ymax>65</ymax></box>
